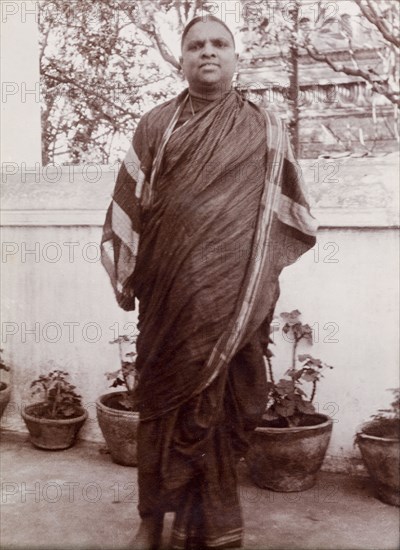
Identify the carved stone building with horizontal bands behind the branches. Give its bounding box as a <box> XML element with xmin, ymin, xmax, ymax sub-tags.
<box><xmin>237</xmin><ymin>13</ymin><xmax>399</xmax><ymax>158</ymax></box>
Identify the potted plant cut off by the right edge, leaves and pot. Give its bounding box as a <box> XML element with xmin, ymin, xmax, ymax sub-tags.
<box><xmin>355</xmin><ymin>388</ymin><xmax>400</xmax><ymax>506</ymax></box>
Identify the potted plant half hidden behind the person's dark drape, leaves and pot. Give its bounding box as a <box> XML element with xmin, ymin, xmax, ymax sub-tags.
<box><xmin>96</xmin><ymin>334</ymin><xmax>139</xmax><ymax>466</ymax></box>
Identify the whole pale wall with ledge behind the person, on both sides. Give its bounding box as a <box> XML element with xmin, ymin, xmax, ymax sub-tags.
<box><xmin>1</xmin><ymin>161</ymin><xmax>399</xmax><ymax>470</ymax></box>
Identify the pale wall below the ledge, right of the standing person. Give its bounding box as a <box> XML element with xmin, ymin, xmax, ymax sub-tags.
<box><xmin>275</xmin><ymin>228</ymin><xmax>399</xmax><ymax>470</ymax></box>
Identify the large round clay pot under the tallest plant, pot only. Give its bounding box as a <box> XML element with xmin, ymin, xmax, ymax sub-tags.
<box><xmin>246</xmin><ymin>414</ymin><xmax>333</xmax><ymax>493</ymax></box>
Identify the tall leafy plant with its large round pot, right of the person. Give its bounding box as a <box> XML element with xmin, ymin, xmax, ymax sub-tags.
<box><xmin>246</xmin><ymin>310</ymin><xmax>332</xmax><ymax>492</ymax></box>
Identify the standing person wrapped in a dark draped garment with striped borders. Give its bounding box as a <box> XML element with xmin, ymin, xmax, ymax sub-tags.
<box><xmin>102</xmin><ymin>12</ymin><xmax>316</xmax><ymax>549</ymax></box>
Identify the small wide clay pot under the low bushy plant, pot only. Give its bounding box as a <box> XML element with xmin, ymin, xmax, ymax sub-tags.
<box><xmin>21</xmin><ymin>403</ymin><xmax>88</xmax><ymax>451</ymax></box>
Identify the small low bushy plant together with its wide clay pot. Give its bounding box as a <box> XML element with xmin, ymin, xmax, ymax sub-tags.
<box><xmin>21</xmin><ymin>369</ymin><xmax>88</xmax><ymax>450</ymax></box>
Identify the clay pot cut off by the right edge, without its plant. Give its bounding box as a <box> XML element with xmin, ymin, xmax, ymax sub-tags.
<box><xmin>357</xmin><ymin>432</ymin><xmax>400</xmax><ymax>506</ymax></box>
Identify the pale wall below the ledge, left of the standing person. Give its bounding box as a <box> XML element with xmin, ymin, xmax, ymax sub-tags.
<box><xmin>2</xmin><ymin>227</ymin><xmax>135</xmax><ymax>439</ymax></box>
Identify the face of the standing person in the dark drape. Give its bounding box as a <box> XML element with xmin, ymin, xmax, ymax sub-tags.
<box><xmin>181</xmin><ymin>21</ymin><xmax>237</xmax><ymax>93</ymax></box>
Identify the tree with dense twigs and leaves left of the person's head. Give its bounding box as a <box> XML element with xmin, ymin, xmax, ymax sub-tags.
<box><xmin>39</xmin><ymin>0</ymin><xmax>203</xmax><ymax>165</ymax></box>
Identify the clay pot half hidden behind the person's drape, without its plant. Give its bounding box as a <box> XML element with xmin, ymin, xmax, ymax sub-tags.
<box><xmin>96</xmin><ymin>392</ymin><xmax>139</xmax><ymax>466</ymax></box>
